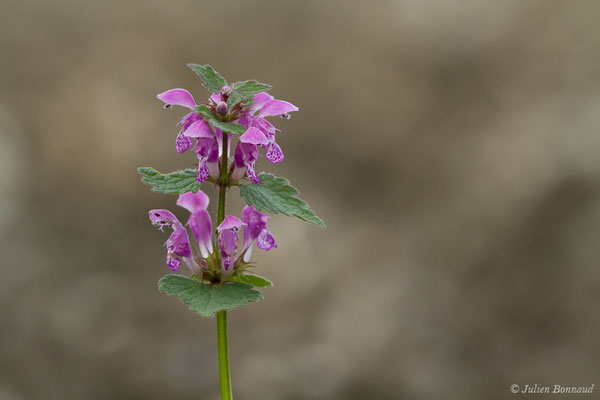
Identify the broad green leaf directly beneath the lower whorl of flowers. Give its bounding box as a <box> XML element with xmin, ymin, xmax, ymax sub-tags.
<box><xmin>158</xmin><ymin>275</ymin><xmax>263</xmax><ymax>318</ymax></box>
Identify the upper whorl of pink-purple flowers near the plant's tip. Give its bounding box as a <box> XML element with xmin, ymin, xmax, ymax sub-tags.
<box><xmin>157</xmin><ymin>86</ymin><xmax>298</xmax><ymax>183</ymax></box>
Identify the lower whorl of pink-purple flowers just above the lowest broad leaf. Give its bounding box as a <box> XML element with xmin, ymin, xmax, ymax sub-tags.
<box><xmin>149</xmin><ymin>191</ymin><xmax>277</xmax><ymax>282</ymax></box>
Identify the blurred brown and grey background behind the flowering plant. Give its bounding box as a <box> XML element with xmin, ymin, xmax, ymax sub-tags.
<box><xmin>0</xmin><ymin>0</ymin><xmax>600</xmax><ymax>400</ymax></box>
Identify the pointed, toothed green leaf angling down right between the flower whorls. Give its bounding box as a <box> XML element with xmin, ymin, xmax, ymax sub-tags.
<box><xmin>240</xmin><ymin>172</ymin><xmax>326</xmax><ymax>229</ymax></box>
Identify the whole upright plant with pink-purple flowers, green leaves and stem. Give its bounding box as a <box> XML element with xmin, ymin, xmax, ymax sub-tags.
<box><xmin>138</xmin><ymin>64</ymin><xmax>325</xmax><ymax>400</ymax></box>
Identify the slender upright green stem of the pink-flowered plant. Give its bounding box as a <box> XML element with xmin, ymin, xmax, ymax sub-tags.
<box><xmin>217</xmin><ymin>132</ymin><xmax>233</xmax><ymax>400</ymax></box>
